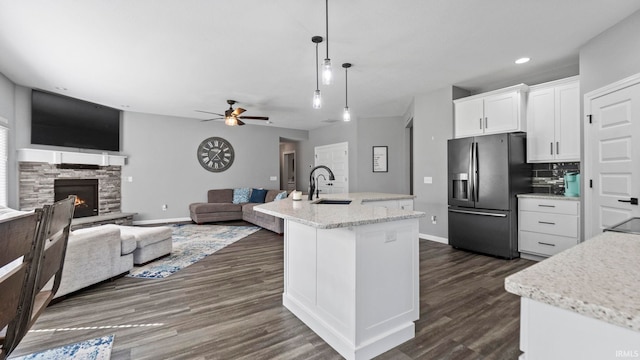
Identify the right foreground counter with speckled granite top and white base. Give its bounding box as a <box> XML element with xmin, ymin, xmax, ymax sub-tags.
<box><xmin>505</xmin><ymin>232</ymin><xmax>640</xmax><ymax>360</ymax></box>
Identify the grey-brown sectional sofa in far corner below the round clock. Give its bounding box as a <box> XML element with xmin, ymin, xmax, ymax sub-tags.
<box><xmin>189</xmin><ymin>189</ymin><xmax>285</xmax><ymax>234</ymax></box>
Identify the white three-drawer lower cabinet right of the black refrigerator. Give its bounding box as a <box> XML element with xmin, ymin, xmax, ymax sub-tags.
<box><xmin>518</xmin><ymin>198</ymin><xmax>580</xmax><ymax>258</ymax></box>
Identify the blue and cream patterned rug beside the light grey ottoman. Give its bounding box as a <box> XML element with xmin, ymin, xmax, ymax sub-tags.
<box><xmin>127</xmin><ymin>224</ymin><xmax>260</xmax><ymax>279</ymax></box>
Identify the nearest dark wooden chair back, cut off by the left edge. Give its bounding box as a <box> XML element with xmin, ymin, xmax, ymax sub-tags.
<box><xmin>0</xmin><ymin>209</ymin><xmax>42</xmax><ymax>359</ymax></box>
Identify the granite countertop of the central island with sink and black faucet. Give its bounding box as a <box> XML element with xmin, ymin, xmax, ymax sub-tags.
<box><xmin>254</xmin><ymin>193</ymin><xmax>425</xmax><ymax>229</ymax></box>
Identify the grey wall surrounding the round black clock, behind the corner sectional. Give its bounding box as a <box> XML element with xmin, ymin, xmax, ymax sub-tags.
<box><xmin>122</xmin><ymin>112</ymin><xmax>307</xmax><ymax>221</ymax></box>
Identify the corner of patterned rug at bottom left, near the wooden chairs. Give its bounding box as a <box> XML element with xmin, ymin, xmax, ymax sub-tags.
<box><xmin>9</xmin><ymin>335</ymin><xmax>114</xmax><ymax>360</ymax></box>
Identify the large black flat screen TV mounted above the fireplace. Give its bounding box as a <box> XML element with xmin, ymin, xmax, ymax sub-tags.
<box><xmin>31</xmin><ymin>90</ymin><xmax>121</xmax><ymax>151</ymax></box>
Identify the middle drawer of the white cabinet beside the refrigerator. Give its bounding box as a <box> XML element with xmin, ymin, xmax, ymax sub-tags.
<box><xmin>518</xmin><ymin>211</ymin><xmax>578</xmax><ymax>238</ymax></box>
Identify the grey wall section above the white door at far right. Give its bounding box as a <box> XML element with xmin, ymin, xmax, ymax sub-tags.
<box><xmin>580</xmin><ymin>11</ymin><xmax>640</xmax><ymax>95</ymax></box>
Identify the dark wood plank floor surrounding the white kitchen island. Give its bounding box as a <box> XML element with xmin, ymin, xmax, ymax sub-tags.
<box><xmin>13</xmin><ymin>224</ymin><xmax>532</xmax><ymax>360</ymax></box>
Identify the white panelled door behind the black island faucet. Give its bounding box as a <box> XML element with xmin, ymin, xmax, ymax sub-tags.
<box><xmin>314</xmin><ymin>142</ymin><xmax>349</xmax><ymax>194</ymax></box>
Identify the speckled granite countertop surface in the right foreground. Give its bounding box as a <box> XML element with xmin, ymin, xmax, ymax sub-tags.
<box><xmin>505</xmin><ymin>232</ymin><xmax>640</xmax><ymax>331</ymax></box>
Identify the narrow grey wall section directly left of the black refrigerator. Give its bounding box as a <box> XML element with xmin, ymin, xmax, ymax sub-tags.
<box><xmin>413</xmin><ymin>87</ymin><xmax>460</xmax><ymax>241</ymax></box>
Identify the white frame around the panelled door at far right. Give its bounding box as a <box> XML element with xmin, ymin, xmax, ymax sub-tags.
<box><xmin>581</xmin><ymin>73</ymin><xmax>640</xmax><ymax>241</ymax></box>
